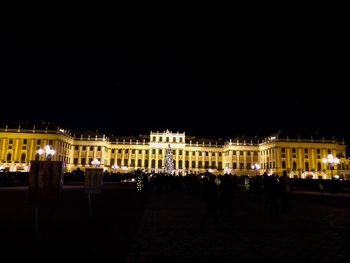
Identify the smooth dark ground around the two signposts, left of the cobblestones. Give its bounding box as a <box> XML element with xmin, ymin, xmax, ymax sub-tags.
<box><xmin>0</xmin><ymin>183</ymin><xmax>146</xmax><ymax>262</ymax></box>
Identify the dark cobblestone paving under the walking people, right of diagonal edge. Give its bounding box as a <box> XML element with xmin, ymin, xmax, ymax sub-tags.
<box><xmin>126</xmin><ymin>192</ymin><xmax>350</xmax><ymax>263</ymax></box>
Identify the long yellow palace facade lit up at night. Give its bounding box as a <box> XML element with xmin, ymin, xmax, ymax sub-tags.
<box><xmin>0</xmin><ymin>124</ymin><xmax>350</xmax><ymax>179</ymax></box>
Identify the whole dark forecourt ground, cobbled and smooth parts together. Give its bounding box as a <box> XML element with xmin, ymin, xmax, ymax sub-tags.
<box><xmin>0</xmin><ymin>183</ymin><xmax>350</xmax><ymax>263</ymax></box>
